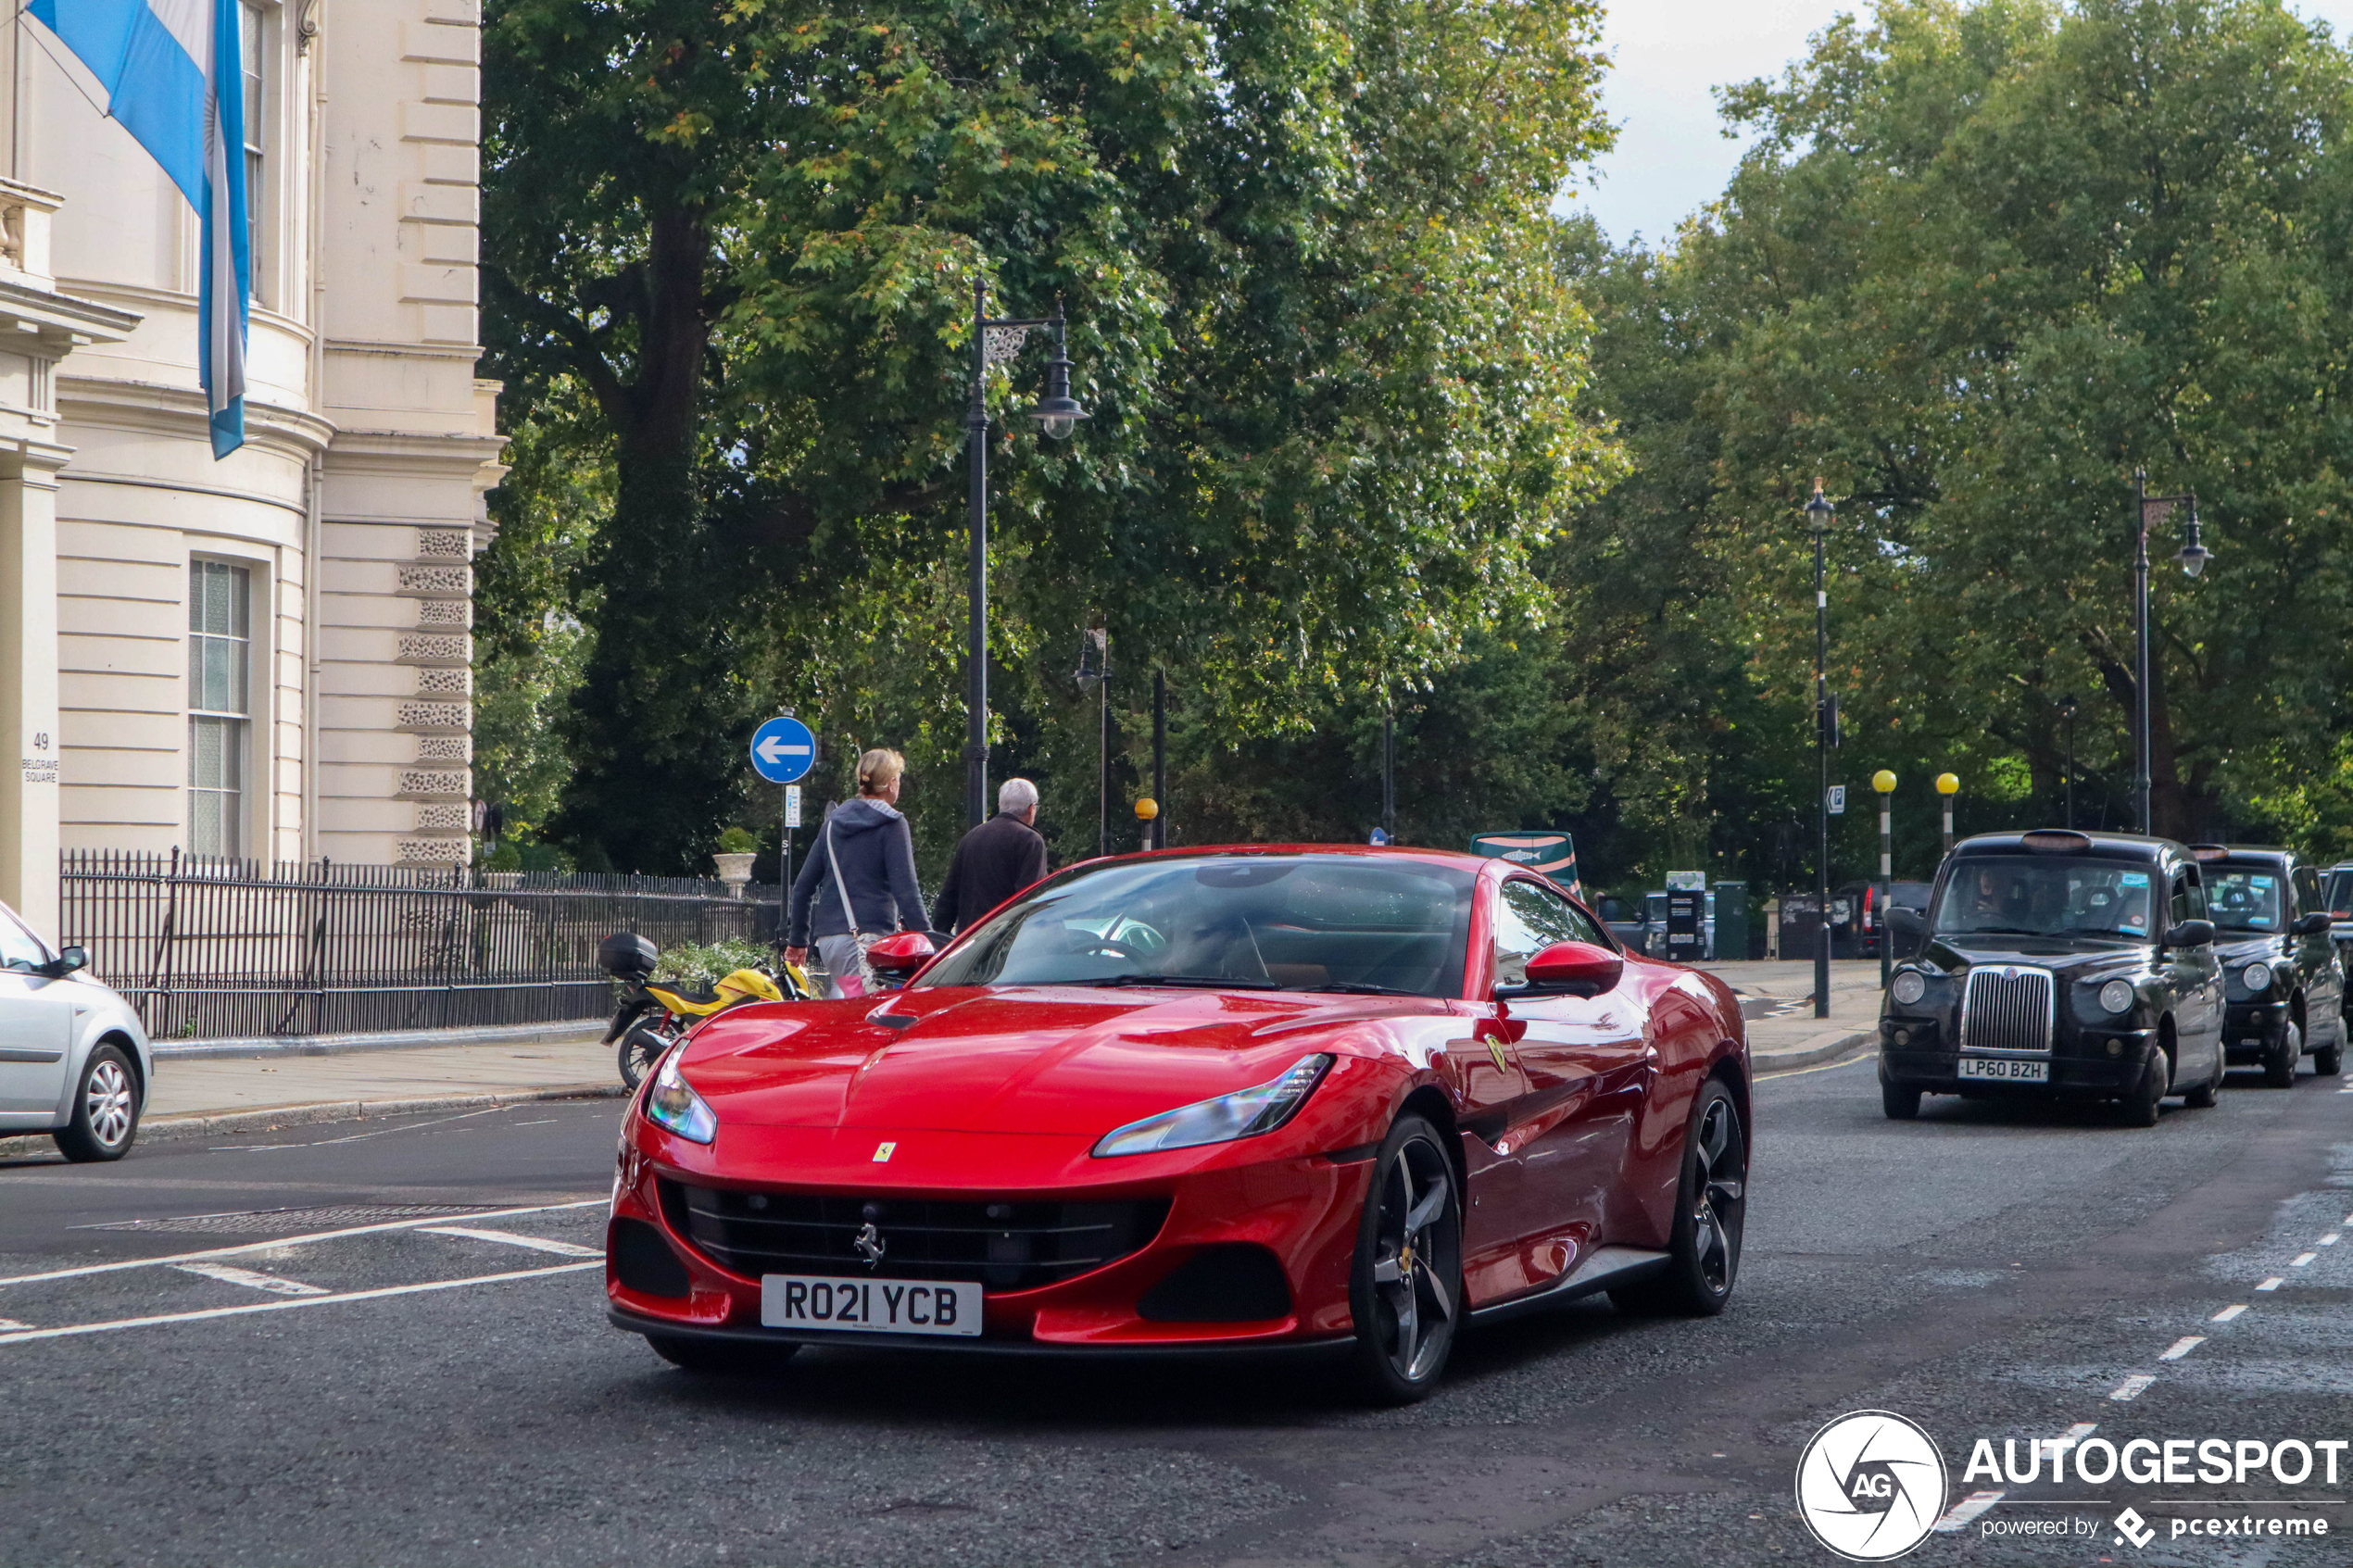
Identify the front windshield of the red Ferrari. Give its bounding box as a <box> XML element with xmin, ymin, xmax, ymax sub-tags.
<box><xmin>920</xmin><ymin>856</ymin><xmax>1478</xmax><ymax>997</ymax></box>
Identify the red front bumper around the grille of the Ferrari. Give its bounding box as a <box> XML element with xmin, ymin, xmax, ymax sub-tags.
<box><xmin>605</xmin><ymin>1114</ymin><xmax>1372</xmax><ymax>1354</ymax></box>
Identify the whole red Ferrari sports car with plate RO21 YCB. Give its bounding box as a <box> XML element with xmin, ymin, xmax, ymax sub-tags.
<box><xmin>605</xmin><ymin>847</ymin><xmax>1751</xmax><ymax>1399</ymax></box>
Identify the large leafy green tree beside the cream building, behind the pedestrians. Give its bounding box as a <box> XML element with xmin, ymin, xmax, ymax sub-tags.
<box><xmin>484</xmin><ymin>0</ymin><xmax>1612</xmax><ymax>870</ymax></box>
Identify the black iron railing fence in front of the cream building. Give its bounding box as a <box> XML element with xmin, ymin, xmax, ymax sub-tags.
<box><xmin>59</xmin><ymin>851</ymin><xmax>776</xmax><ymax>1044</ymax></box>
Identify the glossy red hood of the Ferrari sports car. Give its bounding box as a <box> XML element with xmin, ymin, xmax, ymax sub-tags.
<box><xmin>680</xmin><ymin>985</ymin><xmax>1452</xmax><ymax>1138</ymax></box>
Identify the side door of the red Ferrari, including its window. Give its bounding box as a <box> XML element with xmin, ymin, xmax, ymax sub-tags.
<box><xmin>1494</xmin><ymin>877</ymin><xmax>1655</xmax><ymax>1267</ymax></box>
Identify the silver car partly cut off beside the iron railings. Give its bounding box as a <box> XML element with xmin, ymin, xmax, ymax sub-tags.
<box><xmin>0</xmin><ymin>905</ymin><xmax>156</xmax><ymax>1159</ymax></box>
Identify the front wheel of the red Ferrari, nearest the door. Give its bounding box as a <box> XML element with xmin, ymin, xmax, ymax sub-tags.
<box><xmin>1348</xmin><ymin>1117</ymin><xmax>1464</xmax><ymax>1403</ymax></box>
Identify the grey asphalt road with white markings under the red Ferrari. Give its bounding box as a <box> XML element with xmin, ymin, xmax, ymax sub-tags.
<box><xmin>0</xmin><ymin>1062</ymin><xmax>2353</xmax><ymax>1568</ymax></box>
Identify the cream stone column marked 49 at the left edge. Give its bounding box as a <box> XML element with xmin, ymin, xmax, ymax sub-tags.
<box><xmin>0</xmin><ymin>440</ymin><xmax>73</xmax><ymax>943</ymax></box>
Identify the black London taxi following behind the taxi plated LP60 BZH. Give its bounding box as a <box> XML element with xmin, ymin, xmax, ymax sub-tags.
<box><xmin>2191</xmin><ymin>844</ymin><xmax>2346</xmax><ymax>1088</ymax></box>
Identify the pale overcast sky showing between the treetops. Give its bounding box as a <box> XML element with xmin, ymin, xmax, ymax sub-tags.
<box><xmin>1569</xmin><ymin>0</ymin><xmax>2353</xmax><ymax>242</ymax></box>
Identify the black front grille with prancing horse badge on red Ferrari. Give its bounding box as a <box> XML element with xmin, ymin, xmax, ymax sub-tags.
<box><xmin>661</xmin><ymin>1180</ymin><xmax>1169</xmax><ymax>1290</ymax></box>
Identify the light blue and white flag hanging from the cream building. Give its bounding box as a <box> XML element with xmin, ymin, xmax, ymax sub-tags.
<box><xmin>31</xmin><ymin>0</ymin><xmax>252</xmax><ymax>458</ymax></box>
